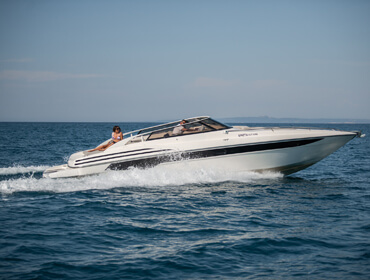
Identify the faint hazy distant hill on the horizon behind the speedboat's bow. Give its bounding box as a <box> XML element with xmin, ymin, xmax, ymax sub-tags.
<box><xmin>217</xmin><ymin>116</ymin><xmax>370</xmax><ymax>123</ymax></box>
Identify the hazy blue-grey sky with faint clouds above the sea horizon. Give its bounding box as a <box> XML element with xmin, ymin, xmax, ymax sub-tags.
<box><xmin>0</xmin><ymin>0</ymin><xmax>370</xmax><ymax>122</ymax></box>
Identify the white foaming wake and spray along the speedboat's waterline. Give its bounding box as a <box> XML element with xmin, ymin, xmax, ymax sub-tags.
<box><xmin>0</xmin><ymin>166</ymin><xmax>283</xmax><ymax>194</ymax></box>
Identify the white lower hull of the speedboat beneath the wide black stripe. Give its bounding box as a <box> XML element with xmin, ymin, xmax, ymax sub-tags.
<box><xmin>44</xmin><ymin>134</ymin><xmax>355</xmax><ymax>178</ymax></box>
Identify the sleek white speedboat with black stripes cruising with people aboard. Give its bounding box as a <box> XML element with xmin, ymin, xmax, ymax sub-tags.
<box><xmin>43</xmin><ymin>116</ymin><xmax>363</xmax><ymax>178</ymax></box>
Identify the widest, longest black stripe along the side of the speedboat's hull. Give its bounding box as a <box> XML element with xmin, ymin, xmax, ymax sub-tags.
<box><xmin>107</xmin><ymin>138</ymin><xmax>322</xmax><ymax>170</ymax></box>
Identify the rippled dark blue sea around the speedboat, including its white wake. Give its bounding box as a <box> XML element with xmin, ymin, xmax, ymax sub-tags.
<box><xmin>0</xmin><ymin>122</ymin><xmax>370</xmax><ymax>280</ymax></box>
